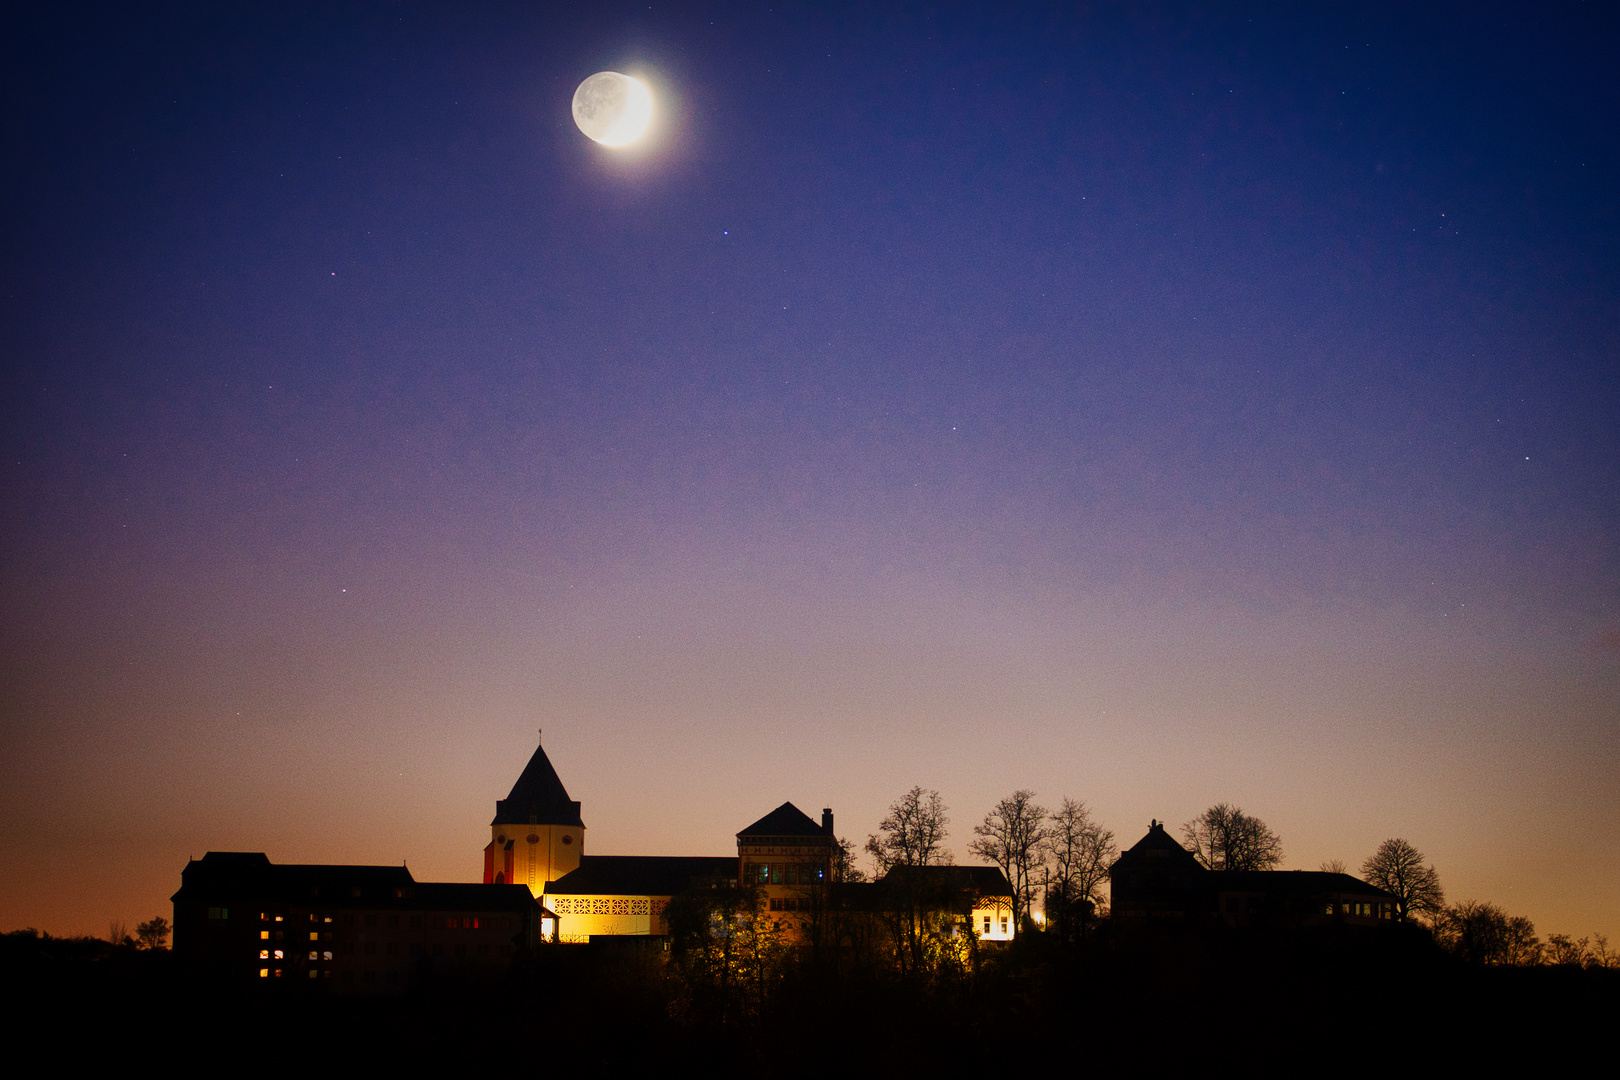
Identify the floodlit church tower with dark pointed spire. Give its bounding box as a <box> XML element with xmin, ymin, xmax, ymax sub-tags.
<box><xmin>484</xmin><ymin>746</ymin><xmax>585</xmax><ymax>899</ymax></box>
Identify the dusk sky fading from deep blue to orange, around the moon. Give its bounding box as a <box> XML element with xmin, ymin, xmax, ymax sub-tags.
<box><xmin>9</xmin><ymin>3</ymin><xmax>1620</xmax><ymax>939</ymax></box>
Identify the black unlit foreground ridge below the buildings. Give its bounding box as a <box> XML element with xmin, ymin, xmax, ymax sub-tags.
<box><xmin>0</xmin><ymin>926</ymin><xmax>1620</xmax><ymax>1077</ymax></box>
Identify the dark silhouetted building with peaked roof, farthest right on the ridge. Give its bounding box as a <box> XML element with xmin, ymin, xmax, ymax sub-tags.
<box><xmin>1108</xmin><ymin>821</ymin><xmax>1395</xmax><ymax>933</ymax></box>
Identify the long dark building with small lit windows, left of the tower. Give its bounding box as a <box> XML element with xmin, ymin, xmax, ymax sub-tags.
<box><xmin>173</xmin><ymin>852</ymin><xmax>554</xmax><ymax>993</ymax></box>
